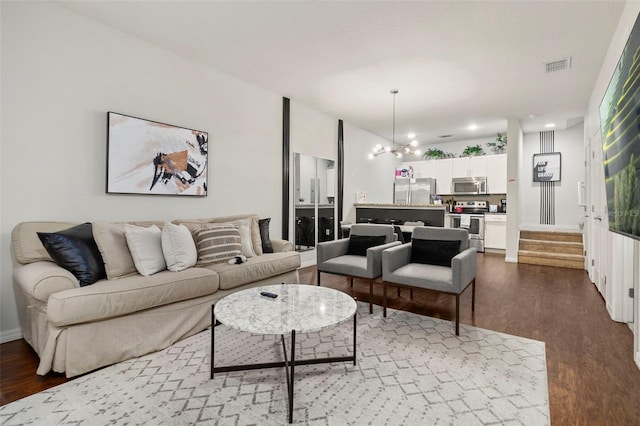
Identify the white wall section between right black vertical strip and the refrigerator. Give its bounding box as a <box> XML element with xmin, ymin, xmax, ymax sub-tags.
<box><xmin>343</xmin><ymin>123</ymin><xmax>402</xmax><ymax>223</ymax></box>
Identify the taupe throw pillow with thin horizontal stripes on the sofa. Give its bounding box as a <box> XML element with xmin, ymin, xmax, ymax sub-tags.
<box><xmin>194</xmin><ymin>226</ymin><xmax>242</xmax><ymax>264</ymax></box>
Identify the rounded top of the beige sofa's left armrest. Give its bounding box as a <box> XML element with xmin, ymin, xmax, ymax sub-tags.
<box><xmin>13</xmin><ymin>261</ymin><xmax>80</xmax><ymax>303</ymax></box>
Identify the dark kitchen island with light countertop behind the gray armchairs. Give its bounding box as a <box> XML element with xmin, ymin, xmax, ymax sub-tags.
<box><xmin>354</xmin><ymin>204</ymin><xmax>445</xmax><ymax>227</ymax></box>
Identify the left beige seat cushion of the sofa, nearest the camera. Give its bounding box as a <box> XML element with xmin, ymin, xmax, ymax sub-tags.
<box><xmin>47</xmin><ymin>268</ymin><xmax>219</xmax><ymax>324</ymax></box>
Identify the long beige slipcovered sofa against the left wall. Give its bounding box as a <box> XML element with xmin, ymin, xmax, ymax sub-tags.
<box><xmin>12</xmin><ymin>215</ymin><xmax>300</xmax><ymax>377</ymax></box>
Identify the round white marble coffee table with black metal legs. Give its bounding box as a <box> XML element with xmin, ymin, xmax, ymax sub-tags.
<box><xmin>211</xmin><ymin>284</ymin><xmax>357</xmax><ymax>423</ymax></box>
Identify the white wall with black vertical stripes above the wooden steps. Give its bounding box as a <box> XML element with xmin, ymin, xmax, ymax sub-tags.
<box><xmin>519</xmin><ymin>123</ymin><xmax>585</xmax><ymax>227</ymax></box>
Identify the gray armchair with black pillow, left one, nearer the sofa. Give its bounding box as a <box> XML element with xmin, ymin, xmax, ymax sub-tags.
<box><xmin>316</xmin><ymin>224</ymin><xmax>400</xmax><ymax>313</ymax></box>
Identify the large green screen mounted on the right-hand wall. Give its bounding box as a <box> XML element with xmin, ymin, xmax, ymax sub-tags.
<box><xmin>600</xmin><ymin>16</ymin><xmax>640</xmax><ymax>240</ymax></box>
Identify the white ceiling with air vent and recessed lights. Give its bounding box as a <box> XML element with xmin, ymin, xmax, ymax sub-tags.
<box><xmin>57</xmin><ymin>1</ymin><xmax>624</xmax><ymax>145</ymax></box>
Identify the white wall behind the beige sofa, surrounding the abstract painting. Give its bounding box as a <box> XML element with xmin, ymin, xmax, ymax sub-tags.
<box><xmin>0</xmin><ymin>2</ymin><xmax>304</xmax><ymax>341</ymax></box>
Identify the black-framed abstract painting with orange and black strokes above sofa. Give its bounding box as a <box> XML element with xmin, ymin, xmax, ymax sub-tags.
<box><xmin>107</xmin><ymin>112</ymin><xmax>209</xmax><ymax>197</ymax></box>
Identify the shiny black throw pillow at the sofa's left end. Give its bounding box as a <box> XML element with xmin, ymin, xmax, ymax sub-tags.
<box><xmin>38</xmin><ymin>223</ymin><xmax>107</xmax><ymax>287</ymax></box>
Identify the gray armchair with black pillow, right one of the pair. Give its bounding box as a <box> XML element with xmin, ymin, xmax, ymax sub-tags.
<box><xmin>382</xmin><ymin>226</ymin><xmax>476</xmax><ymax>336</ymax></box>
